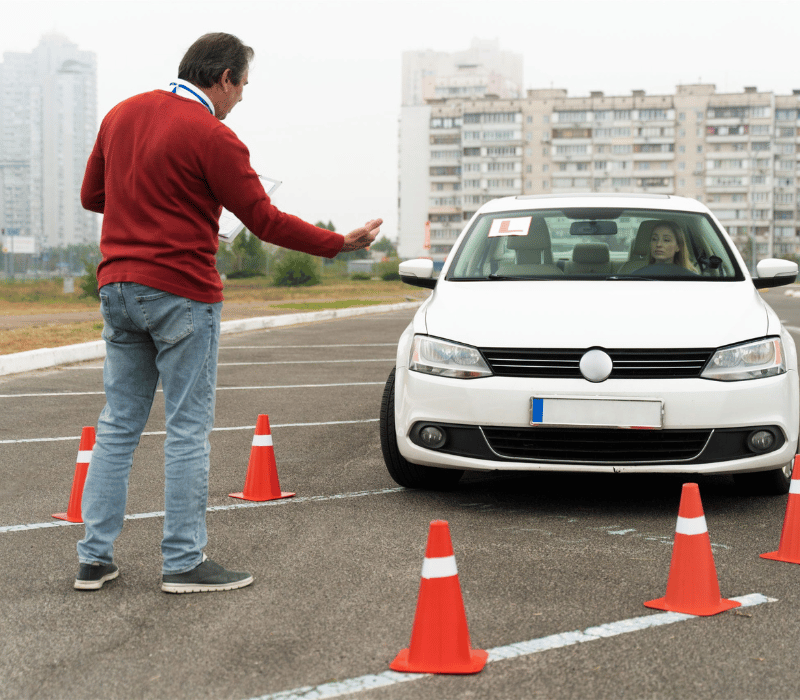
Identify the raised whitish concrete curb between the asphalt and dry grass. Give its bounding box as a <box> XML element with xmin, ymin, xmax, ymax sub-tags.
<box><xmin>0</xmin><ymin>301</ymin><xmax>422</xmax><ymax>376</ymax></box>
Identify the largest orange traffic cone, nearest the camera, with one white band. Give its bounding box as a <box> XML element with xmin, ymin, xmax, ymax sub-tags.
<box><xmin>389</xmin><ymin>520</ymin><xmax>489</xmax><ymax>673</ymax></box>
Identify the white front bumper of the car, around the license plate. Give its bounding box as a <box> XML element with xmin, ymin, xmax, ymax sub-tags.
<box><xmin>395</xmin><ymin>367</ymin><xmax>800</xmax><ymax>474</ymax></box>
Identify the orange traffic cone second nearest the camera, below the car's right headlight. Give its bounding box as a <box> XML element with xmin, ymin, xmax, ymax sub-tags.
<box><xmin>645</xmin><ymin>484</ymin><xmax>741</xmax><ymax>615</ymax></box>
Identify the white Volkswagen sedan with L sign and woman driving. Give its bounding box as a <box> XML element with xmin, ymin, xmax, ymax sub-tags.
<box><xmin>380</xmin><ymin>194</ymin><xmax>800</xmax><ymax>493</ymax></box>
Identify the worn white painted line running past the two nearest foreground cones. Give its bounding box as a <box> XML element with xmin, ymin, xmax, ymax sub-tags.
<box><xmin>249</xmin><ymin>593</ymin><xmax>776</xmax><ymax>700</ymax></box>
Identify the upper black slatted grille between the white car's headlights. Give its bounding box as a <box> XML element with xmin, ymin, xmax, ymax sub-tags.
<box><xmin>480</xmin><ymin>348</ymin><xmax>714</xmax><ymax>379</ymax></box>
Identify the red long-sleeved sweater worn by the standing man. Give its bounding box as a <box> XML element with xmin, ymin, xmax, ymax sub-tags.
<box><xmin>81</xmin><ymin>90</ymin><xmax>344</xmax><ymax>303</ymax></box>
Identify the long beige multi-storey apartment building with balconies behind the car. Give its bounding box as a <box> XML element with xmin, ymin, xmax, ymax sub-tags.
<box><xmin>398</xmin><ymin>84</ymin><xmax>800</xmax><ymax>261</ymax></box>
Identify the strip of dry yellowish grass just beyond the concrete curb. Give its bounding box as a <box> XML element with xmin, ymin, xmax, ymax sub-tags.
<box><xmin>0</xmin><ymin>278</ymin><xmax>425</xmax><ymax>355</ymax></box>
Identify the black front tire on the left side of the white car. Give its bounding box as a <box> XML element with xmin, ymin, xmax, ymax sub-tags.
<box><xmin>380</xmin><ymin>369</ymin><xmax>464</xmax><ymax>491</ymax></box>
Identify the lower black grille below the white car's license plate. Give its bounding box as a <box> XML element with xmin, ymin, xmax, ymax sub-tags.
<box><xmin>483</xmin><ymin>427</ymin><xmax>713</xmax><ymax>464</ymax></box>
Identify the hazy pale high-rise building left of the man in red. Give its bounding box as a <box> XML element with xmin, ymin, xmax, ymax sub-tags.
<box><xmin>0</xmin><ymin>34</ymin><xmax>98</xmax><ymax>250</ymax></box>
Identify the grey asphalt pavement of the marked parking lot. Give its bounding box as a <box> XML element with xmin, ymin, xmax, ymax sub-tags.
<box><xmin>0</xmin><ymin>290</ymin><xmax>800</xmax><ymax>700</ymax></box>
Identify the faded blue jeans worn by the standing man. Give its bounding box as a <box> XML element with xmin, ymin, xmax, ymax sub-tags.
<box><xmin>78</xmin><ymin>282</ymin><xmax>222</xmax><ymax>574</ymax></box>
